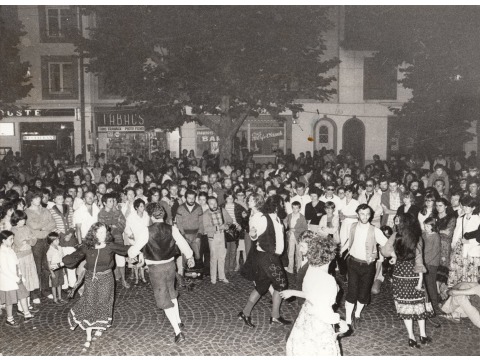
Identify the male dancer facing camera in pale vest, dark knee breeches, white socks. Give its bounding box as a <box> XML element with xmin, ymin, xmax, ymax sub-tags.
<box><xmin>342</xmin><ymin>204</ymin><xmax>395</xmax><ymax>337</ymax></box>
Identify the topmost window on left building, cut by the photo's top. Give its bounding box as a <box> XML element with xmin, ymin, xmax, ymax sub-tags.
<box><xmin>38</xmin><ymin>6</ymin><xmax>78</xmax><ymax>42</ymax></box>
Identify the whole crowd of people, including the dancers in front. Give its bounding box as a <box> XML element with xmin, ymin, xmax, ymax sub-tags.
<box><xmin>0</xmin><ymin>149</ymin><xmax>480</xmax><ymax>355</ymax></box>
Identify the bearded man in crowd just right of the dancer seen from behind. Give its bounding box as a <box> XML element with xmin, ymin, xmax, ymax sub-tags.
<box><xmin>176</xmin><ymin>190</ymin><xmax>203</xmax><ymax>267</ymax></box>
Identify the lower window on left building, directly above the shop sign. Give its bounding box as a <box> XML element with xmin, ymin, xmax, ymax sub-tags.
<box><xmin>42</xmin><ymin>56</ymin><xmax>78</xmax><ymax>99</ymax></box>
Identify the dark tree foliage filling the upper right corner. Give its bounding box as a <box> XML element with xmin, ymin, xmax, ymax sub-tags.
<box><xmin>346</xmin><ymin>6</ymin><xmax>480</xmax><ymax>153</ymax></box>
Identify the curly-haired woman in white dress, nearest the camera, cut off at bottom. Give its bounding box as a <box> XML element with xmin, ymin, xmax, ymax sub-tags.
<box><xmin>280</xmin><ymin>236</ymin><xmax>348</xmax><ymax>356</ymax></box>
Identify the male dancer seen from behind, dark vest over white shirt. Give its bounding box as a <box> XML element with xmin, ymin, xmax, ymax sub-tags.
<box><xmin>128</xmin><ymin>203</ymin><xmax>195</xmax><ymax>343</ymax></box>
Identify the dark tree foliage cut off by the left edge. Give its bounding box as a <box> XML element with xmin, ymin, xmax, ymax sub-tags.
<box><xmin>0</xmin><ymin>6</ymin><xmax>33</xmax><ymax>119</ymax></box>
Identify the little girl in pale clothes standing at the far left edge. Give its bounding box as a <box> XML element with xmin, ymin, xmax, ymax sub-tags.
<box><xmin>0</xmin><ymin>230</ymin><xmax>34</xmax><ymax>327</ymax></box>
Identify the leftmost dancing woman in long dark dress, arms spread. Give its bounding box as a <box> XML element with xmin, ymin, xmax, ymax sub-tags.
<box><xmin>58</xmin><ymin>222</ymin><xmax>130</xmax><ymax>348</ymax></box>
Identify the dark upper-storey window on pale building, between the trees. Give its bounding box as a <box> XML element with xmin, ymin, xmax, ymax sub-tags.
<box><xmin>363</xmin><ymin>57</ymin><xmax>397</xmax><ymax>100</ymax></box>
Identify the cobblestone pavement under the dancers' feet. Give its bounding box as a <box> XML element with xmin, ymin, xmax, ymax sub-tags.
<box><xmin>0</xmin><ymin>274</ymin><xmax>480</xmax><ymax>356</ymax></box>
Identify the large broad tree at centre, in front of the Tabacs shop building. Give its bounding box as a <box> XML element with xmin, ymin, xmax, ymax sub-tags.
<box><xmin>79</xmin><ymin>6</ymin><xmax>338</xmax><ymax>158</ymax></box>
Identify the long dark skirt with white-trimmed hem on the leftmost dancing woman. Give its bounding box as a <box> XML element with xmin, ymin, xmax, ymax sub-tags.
<box><xmin>68</xmin><ymin>270</ymin><xmax>115</xmax><ymax>330</ymax></box>
